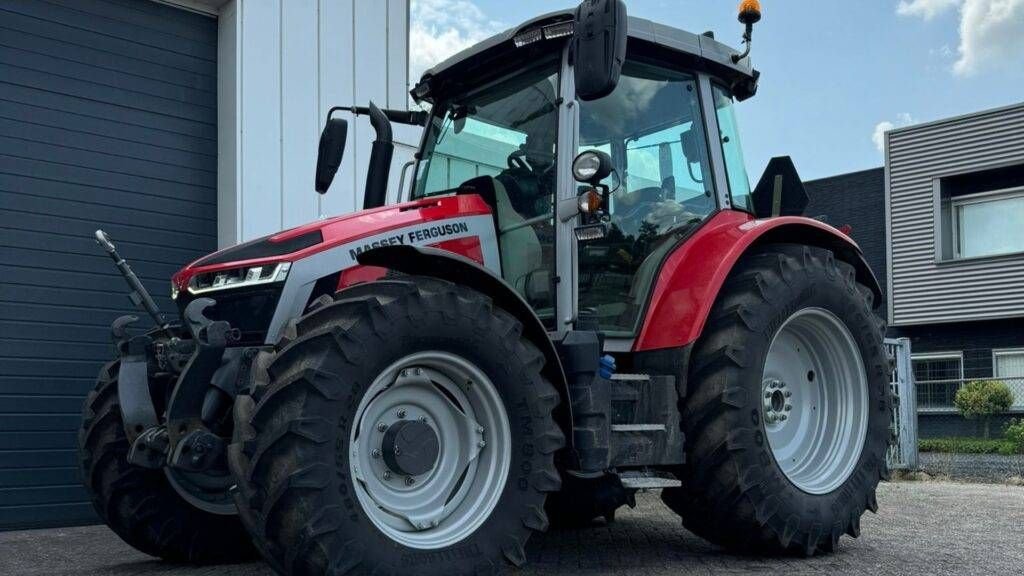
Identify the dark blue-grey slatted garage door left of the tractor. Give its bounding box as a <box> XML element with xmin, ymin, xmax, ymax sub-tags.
<box><xmin>0</xmin><ymin>0</ymin><xmax>217</xmax><ymax>529</ymax></box>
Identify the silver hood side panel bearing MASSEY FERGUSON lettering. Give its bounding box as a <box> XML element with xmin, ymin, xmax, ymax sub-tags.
<box><xmin>260</xmin><ymin>215</ymin><xmax>502</xmax><ymax>344</ymax></box>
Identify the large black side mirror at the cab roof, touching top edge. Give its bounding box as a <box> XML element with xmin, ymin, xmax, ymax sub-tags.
<box><xmin>572</xmin><ymin>0</ymin><xmax>629</xmax><ymax>101</ymax></box>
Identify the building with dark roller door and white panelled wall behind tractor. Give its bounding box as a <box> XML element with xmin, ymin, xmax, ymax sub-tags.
<box><xmin>0</xmin><ymin>0</ymin><xmax>418</xmax><ymax>529</ymax></box>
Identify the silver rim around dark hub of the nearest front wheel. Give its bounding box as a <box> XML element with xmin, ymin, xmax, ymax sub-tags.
<box><xmin>348</xmin><ymin>351</ymin><xmax>512</xmax><ymax>549</ymax></box>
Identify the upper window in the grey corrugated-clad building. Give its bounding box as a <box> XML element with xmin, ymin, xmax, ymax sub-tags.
<box><xmin>952</xmin><ymin>189</ymin><xmax>1024</xmax><ymax>258</ymax></box>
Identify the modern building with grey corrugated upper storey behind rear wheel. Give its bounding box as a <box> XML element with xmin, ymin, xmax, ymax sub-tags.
<box><xmin>808</xmin><ymin>104</ymin><xmax>1024</xmax><ymax>437</ymax></box>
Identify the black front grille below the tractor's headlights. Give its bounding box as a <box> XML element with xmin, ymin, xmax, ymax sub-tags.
<box><xmin>177</xmin><ymin>283</ymin><xmax>284</xmax><ymax>345</ymax></box>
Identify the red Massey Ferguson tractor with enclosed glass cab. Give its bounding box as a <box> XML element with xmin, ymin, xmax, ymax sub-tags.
<box><xmin>80</xmin><ymin>0</ymin><xmax>891</xmax><ymax>575</ymax></box>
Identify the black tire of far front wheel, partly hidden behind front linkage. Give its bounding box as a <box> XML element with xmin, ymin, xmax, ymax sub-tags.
<box><xmin>79</xmin><ymin>361</ymin><xmax>257</xmax><ymax>564</ymax></box>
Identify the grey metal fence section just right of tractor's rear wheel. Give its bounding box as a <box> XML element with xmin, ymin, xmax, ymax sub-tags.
<box><xmin>886</xmin><ymin>338</ymin><xmax>918</xmax><ymax>469</ymax></box>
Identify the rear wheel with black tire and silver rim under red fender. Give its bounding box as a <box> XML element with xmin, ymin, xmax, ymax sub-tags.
<box><xmin>663</xmin><ymin>245</ymin><xmax>891</xmax><ymax>556</ymax></box>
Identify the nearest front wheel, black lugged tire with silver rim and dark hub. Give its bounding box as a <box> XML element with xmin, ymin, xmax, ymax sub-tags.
<box><xmin>229</xmin><ymin>277</ymin><xmax>564</xmax><ymax>576</ymax></box>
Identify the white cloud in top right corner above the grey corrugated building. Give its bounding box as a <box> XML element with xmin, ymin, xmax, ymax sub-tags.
<box><xmin>896</xmin><ymin>0</ymin><xmax>1024</xmax><ymax>76</ymax></box>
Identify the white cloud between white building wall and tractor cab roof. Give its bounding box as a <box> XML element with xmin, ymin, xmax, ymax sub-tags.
<box><xmin>409</xmin><ymin>0</ymin><xmax>502</xmax><ymax>84</ymax></box>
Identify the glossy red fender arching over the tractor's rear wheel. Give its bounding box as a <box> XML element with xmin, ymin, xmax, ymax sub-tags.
<box><xmin>633</xmin><ymin>210</ymin><xmax>882</xmax><ymax>352</ymax></box>
